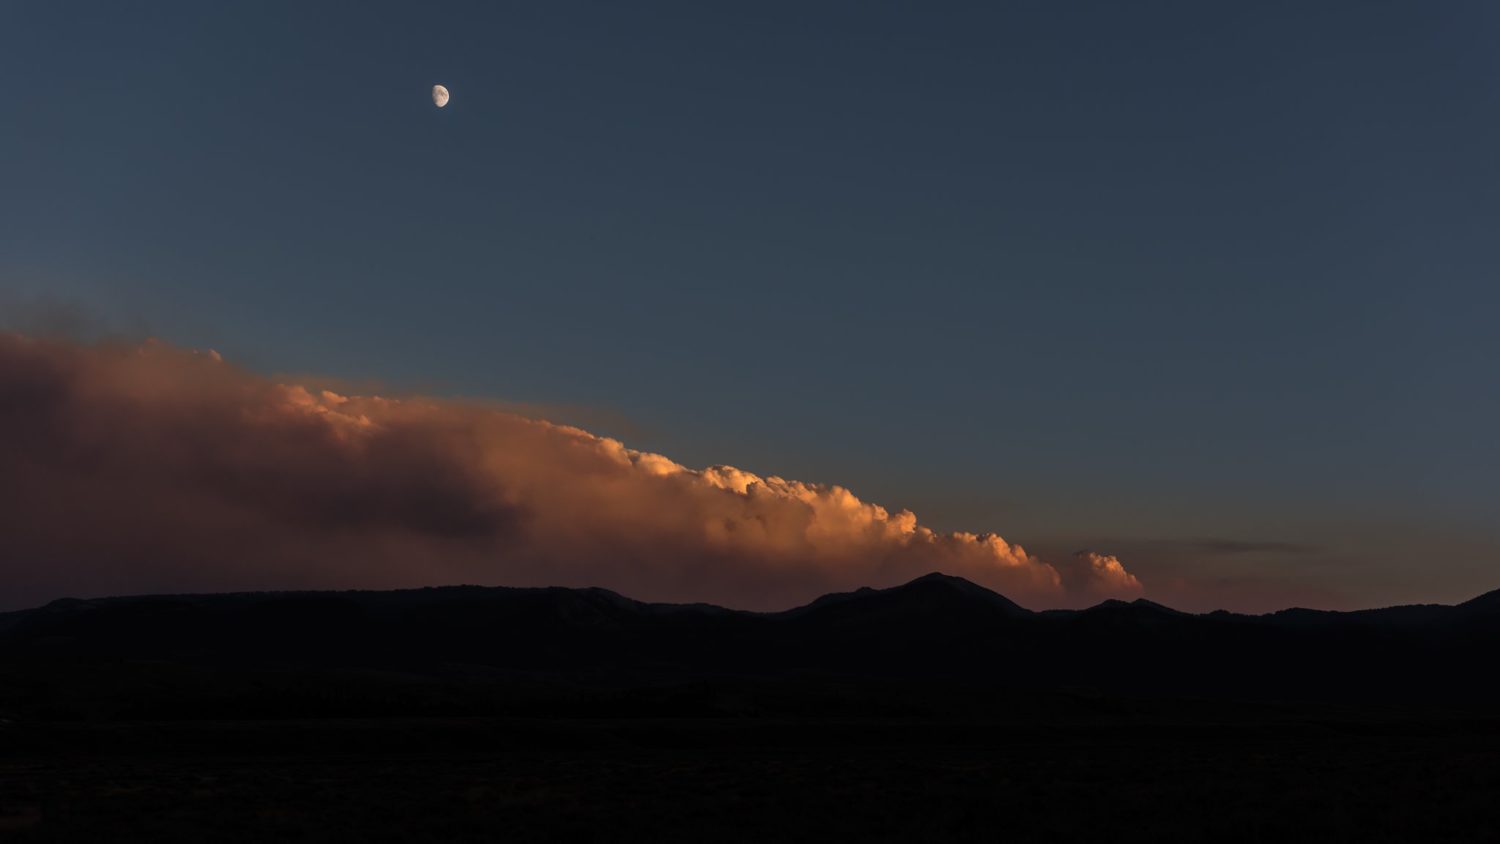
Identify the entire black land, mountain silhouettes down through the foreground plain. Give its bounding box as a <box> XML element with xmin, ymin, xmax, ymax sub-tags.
<box><xmin>0</xmin><ymin>576</ymin><xmax>1500</xmax><ymax>841</ymax></box>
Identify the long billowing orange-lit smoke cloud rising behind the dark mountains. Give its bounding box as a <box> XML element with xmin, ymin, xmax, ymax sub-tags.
<box><xmin>0</xmin><ymin>336</ymin><xmax>1140</xmax><ymax>609</ymax></box>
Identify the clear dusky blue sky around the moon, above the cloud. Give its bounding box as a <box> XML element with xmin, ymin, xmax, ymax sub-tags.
<box><xmin>0</xmin><ymin>0</ymin><xmax>1500</xmax><ymax>604</ymax></box>
